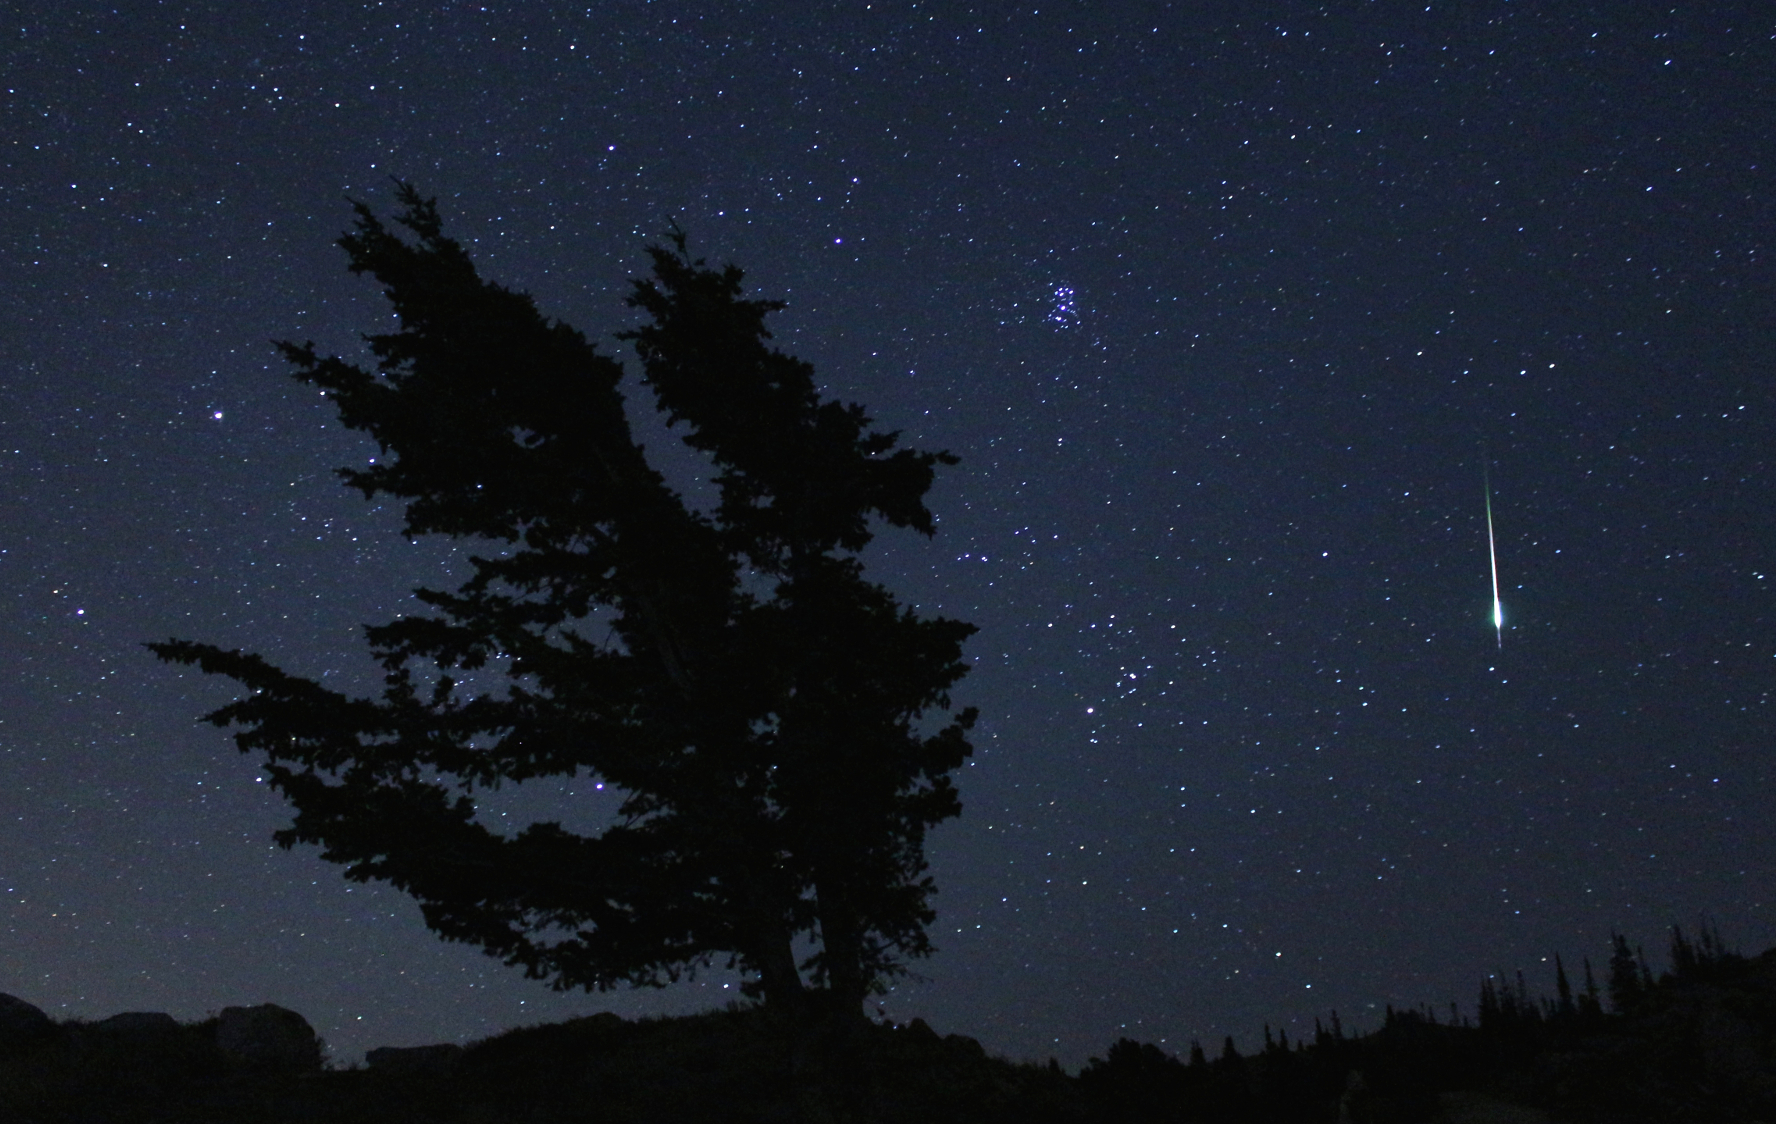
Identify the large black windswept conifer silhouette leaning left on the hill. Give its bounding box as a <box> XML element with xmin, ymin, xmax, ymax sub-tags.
<box><xmin>149</xmin><ymin>185</ymin><xmax>973</xmax><ymax>1012</ymax></box>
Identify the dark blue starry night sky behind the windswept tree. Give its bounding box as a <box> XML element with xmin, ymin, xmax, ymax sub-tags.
<box><xmin>0</xmin><ymin>0</ymin><xmax>1776</xmax><ymax>1065</ymax></box>
